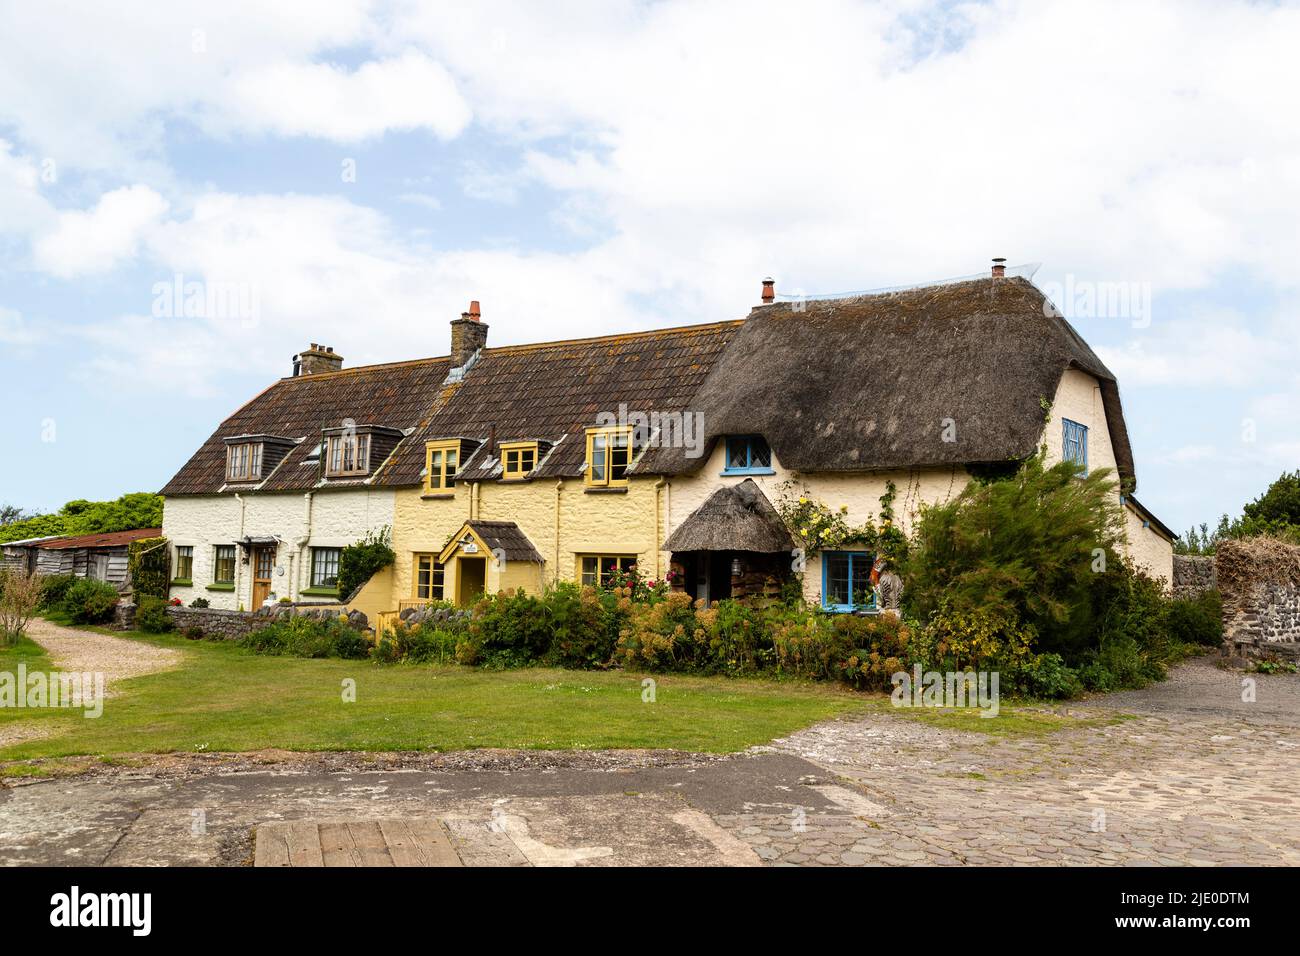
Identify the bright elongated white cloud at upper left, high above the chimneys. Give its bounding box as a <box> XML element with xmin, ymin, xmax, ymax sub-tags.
<box><xmin>222</xmin><ymin>53</ymin><xmax>471</xmax><ymax>143</ymax></box>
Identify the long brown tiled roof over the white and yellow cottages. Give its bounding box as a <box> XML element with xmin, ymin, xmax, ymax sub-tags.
<box><xmin>161</xmin><ymin>321</ymin><xmax>741</xmax><ymax>497</ymax></box>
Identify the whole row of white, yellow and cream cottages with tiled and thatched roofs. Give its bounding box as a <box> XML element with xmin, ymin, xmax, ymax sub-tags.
<box><xmin>163</xmin><ymin>267</ymin><xmax>1173</xmax><ymax>614</ymax></box>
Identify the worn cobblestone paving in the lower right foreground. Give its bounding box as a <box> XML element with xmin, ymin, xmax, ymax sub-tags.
<box><xmin>718</xmin><ymin>662</ymin><xmax>1300</xmax><ymax>866</ymax></box>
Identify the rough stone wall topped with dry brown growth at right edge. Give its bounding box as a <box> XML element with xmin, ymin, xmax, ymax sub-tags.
<box><xmin>1214</xmin><ymin>538</ymin><xmax>1300</xmax><ymax>657</ymax></box>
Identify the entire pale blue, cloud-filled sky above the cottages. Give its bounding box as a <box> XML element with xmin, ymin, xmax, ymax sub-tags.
<box><xmin>0</xmin><ymin>0</ymin><xmax>1300</xmax><ymax>529</ymax></box>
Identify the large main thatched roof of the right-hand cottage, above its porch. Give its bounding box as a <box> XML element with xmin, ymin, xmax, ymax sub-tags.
<box><xmin>633</xmin><ymin>278</ymin><xmax>1134</xmax><ymax>483</ymax></box>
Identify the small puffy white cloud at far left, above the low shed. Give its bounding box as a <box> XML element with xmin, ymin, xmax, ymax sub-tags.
<box><xmin>33</xmin><ymin>186</ymin><xmax>168</xmax><ymax>278</ymax></box>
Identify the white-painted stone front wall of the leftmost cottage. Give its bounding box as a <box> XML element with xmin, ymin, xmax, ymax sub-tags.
<box><xmin>163</xmin><ymin>489</ymin><xmax>394</xmax><ymax>610</ymax></box>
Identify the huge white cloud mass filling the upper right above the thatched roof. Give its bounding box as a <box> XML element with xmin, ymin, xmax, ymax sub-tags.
<box><xmin>391</xmin><ymin>0</ymin><xmax>1300</xmax><ymax>302</ymax></box>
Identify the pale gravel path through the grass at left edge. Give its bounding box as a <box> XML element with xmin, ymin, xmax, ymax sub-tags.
<box><xmin>0</xmin><ymin>618</ymin><xmax>185</xmax><ymax>748</ymax></box>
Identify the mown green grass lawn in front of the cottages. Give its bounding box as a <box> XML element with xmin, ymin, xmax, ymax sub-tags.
<box><xmin>0</xmin><ymin>632</ymin><xmax>867</xmax><ymax>761</ymax></box>
